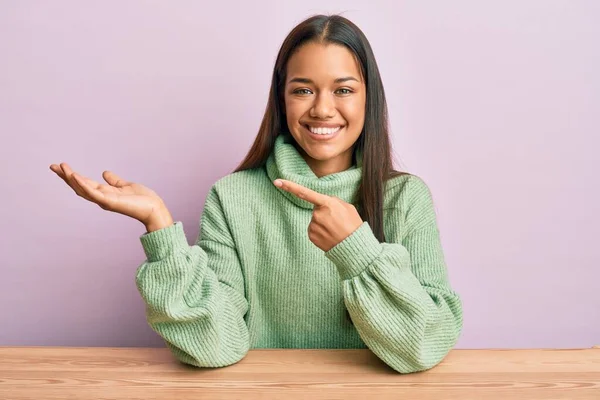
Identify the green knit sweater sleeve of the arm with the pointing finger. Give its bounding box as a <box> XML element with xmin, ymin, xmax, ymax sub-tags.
<box><xmin>325</xmin><ymin>176</ymin><xmax>463</xmax><ymax>373</ymax></box>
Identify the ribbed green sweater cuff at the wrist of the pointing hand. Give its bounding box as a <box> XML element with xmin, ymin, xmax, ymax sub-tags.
<box><xmin>325</xmin><ymin>221</ymin><xmax>383</xmax><ymax>279</ymax></box>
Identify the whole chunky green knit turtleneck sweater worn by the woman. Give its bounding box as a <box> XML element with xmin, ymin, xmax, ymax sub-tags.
<box><xmin>136</xmin><ymin>135</ymin><xmax>462</xmax><ymax>373</ymax></box>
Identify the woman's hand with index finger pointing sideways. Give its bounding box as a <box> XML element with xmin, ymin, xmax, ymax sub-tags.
<box><xmin>273</xmin><ymin>179</ymin><xmax>363</xmax><ymax>251</ymax></box>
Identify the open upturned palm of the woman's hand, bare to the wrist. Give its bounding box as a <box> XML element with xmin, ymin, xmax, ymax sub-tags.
<box><xmin>50</xmin><ymin>162</ymin><xmax>173</xmax><ymax>232</ymax></box>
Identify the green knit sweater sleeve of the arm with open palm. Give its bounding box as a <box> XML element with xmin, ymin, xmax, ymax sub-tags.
<box><xmin>136</xmin><ymin>186</ymin><xmax>249</xmax><ymax>367</ymax></box>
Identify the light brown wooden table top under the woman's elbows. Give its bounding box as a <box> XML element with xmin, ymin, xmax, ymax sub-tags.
<box><xmin>0</xmin><ymin>347</ymin><xmax>600</xmax><ymax>400</ymax></box>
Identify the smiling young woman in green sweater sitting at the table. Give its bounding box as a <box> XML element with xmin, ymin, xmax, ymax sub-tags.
<box><xmin>50</xmin><ymin>15</ymin><xmax>462</xmax><ymax>373</ymax></box>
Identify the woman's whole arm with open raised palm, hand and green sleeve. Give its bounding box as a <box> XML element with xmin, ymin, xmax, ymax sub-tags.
<box><xmin>50</xmin><ymin>163</ymin><xmax>250</xmax><ymax>367</ymax></box>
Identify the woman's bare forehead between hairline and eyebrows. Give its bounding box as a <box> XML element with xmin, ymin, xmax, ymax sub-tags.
<box><xmin>287</xmin><ymin>43</ymin><xmax>361</xmax><ymax>83</ymax></box>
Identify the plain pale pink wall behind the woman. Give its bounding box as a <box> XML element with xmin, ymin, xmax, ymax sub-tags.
<box><xmin>0</xmin><ymin>0</ymin><xmax>600</xmax><ymax>348</ymax></box>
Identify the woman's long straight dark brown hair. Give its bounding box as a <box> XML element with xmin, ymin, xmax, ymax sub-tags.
<box><xmin>234</xmin><ymin>15</ymin><xmax>405</xmax><ymax>242</ymax></box>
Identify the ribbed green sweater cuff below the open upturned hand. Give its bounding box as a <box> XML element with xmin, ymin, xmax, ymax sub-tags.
<box><xmin>140</xmin><ymin>222</ymin><xmax>189</xmax><ymax>262</ymax></box>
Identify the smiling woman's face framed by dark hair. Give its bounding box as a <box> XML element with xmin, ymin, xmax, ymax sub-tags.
<box><xmin>284</xmin><ymin>43</ymin><xmax>366</xmax><ymax>177</ymax></box>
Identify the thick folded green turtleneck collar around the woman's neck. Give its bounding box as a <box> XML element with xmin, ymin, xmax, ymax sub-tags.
<box><xmin>265</xmin><ymin>133</ymin><xmax>362</xmax><ymax>209</ymax></box>
